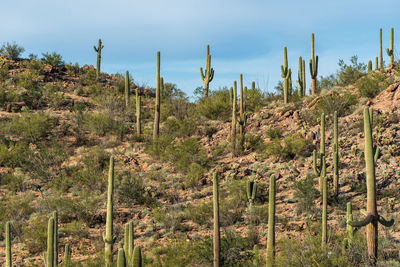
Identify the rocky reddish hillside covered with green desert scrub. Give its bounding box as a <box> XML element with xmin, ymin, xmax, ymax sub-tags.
<box><xmin>0</xmin><ymin>56</ymin><xmax>400</xmax><ymax>266</ymax></box>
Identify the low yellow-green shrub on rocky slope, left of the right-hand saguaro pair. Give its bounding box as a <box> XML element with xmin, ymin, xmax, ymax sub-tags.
<box><xmin>265</xmin><ymin>134</ymin><xmax>310</xmax><ymax>159</ymax></box>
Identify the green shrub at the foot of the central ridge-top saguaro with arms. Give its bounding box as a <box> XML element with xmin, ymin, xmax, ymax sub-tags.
<box><xmin>196</xmin><ymin>87</ymin><xmax>232</xmax><ymax>121</ymax></box>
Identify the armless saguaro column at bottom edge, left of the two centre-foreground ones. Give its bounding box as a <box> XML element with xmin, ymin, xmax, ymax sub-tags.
<box><xmin>213</xmin><ymin>173</ymin><xmax>221</xmax><ymax>267</ymax></box>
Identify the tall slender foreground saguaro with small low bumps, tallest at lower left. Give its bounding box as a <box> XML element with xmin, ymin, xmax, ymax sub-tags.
<box><xmin>103</xmin><ymin>156</ymin><xmax>115</xmax><ymax>267</ymax></box>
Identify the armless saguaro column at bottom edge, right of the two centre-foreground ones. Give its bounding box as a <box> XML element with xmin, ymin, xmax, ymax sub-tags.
<box><xmin>267</xmin><ymin>175</ymin><xmax>276</xmax><ymax>267</ymax></box>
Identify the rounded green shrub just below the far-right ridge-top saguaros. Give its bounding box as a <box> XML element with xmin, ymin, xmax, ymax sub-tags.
<box><xmin>356</xmin><ymin>72</ymin><xmax>391</xmax><ymax>98</ymax></box>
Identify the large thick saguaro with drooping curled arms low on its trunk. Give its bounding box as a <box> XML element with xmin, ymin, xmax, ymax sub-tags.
<box><xmin>347</xmin><ymin>108</ymin><xmax>394</xmax><ymax>266</ymax></box>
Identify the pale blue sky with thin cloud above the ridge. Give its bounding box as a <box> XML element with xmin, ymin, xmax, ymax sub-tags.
<box><xmin>0</xmin><ymin>0</ymin><xmax>400</xmax><ymax>99</ymax></box>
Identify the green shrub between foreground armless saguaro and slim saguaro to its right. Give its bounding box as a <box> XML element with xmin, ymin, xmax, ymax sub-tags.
<box><xmin>293</xmin><ymin>175</ymin><xmax>319</xmax><ymax>215</ymax></box>
